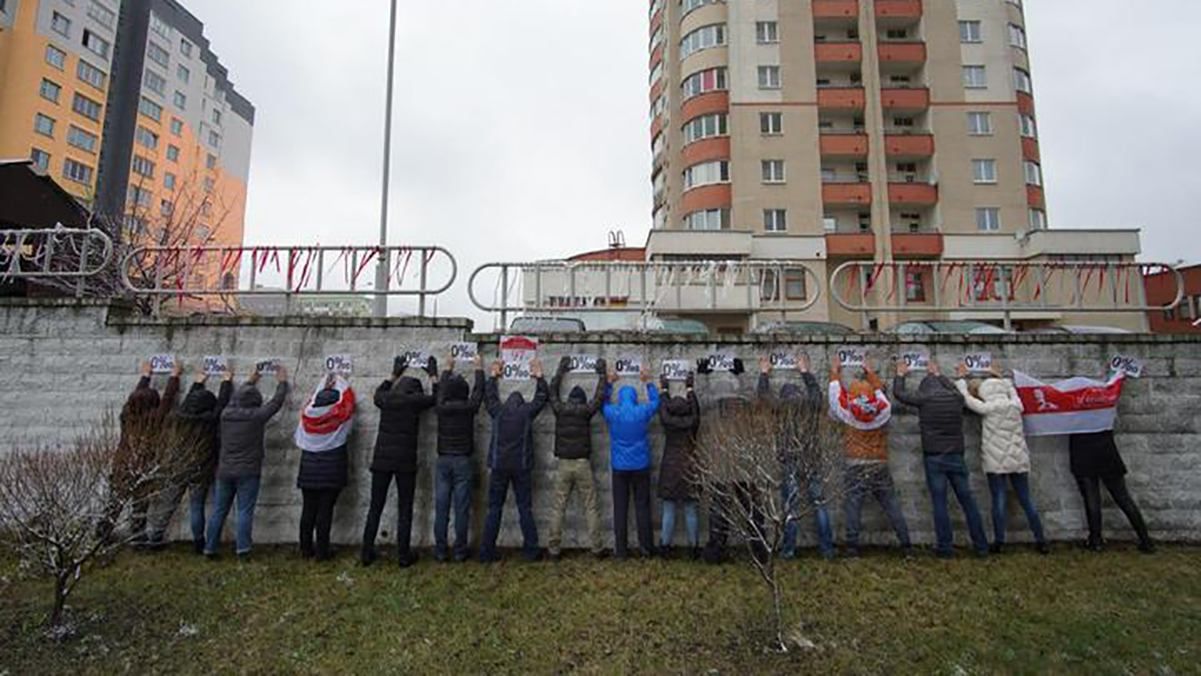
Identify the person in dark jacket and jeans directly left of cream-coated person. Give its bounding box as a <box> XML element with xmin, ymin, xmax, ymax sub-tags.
<box><xmin>892</xmin><ymin>359</ymin><xmax>988</xmax><ymax>558</ymax></box>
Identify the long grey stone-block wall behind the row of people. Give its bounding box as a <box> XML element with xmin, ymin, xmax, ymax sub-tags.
<box><xmin>0</xmin><ymin>300</ymin><xmax>1201</xmax><ymax>546</ymax></box>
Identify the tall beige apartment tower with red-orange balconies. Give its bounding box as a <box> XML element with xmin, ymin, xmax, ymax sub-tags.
<box><xmin>647</xmin><ymin>0</ymin><xmax>1145</xmax><ymax>330</ymax></box>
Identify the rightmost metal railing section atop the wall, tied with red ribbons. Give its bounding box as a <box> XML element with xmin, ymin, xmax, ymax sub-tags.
<box><xmin>830</xmin><ymin>261</ymin><xmax>1185</xmax><ymax>329</ymax></box>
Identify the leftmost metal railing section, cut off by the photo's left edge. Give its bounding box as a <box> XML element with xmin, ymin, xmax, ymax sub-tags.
<box><xmin>0</xmin><ymin>226</ymin><xmax>113</xmax><ymax>295</ymax></box>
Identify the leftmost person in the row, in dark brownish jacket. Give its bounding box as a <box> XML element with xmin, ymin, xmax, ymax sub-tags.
<box><xmin>97</xmin><ymin>361</ymin><xmax>183</xmax><ymax>546</ymax></box>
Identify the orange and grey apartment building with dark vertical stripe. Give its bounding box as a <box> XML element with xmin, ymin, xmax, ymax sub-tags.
<box><xmin>0</xmin><ymin>0</ymin><xmax>255</xmax><ymax>256</ymax></box>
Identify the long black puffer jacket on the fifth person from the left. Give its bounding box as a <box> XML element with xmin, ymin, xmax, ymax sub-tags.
<box><xmin>371</xmin><ymin>376</ymin><xmax>437</xmax><ymax>472</ymax></box>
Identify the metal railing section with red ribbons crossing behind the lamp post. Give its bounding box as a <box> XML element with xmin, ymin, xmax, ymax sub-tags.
<box><xmin>121</xmin><ymin>246</ymin><xmax>459</xmax><ymax>316</ymax></box>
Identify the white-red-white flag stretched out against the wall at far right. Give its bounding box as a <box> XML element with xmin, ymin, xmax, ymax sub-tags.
<box><xmin>1014</xmin><ymin>371</ymin><xmax>1125</xmax><ymax>437</ymax></box>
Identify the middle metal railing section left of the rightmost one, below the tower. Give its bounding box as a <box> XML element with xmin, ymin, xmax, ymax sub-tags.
<box><xmin>467</xmin><ymin>259</ymin><xmax>823</xmax><ymax>325</ymax></box>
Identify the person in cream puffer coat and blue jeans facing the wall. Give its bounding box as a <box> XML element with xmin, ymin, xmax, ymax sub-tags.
<box><xmin>955</xmin><ymin>364</ymin><xmax>1050</xmax><ymax>554</ymax></box>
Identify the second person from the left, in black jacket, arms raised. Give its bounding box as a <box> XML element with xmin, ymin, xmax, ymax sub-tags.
<box><xmin>150</xmin><ymin>369</ymin><xmax>233</xmax><ymax>554</ymax></box>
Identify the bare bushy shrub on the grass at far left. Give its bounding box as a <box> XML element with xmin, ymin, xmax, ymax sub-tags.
<box><xmin>0</xmin><ymin>413</ymin><xmax>198</xmax><ymax>634</ymax></box>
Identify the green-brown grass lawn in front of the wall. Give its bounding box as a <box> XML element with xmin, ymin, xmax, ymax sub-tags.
<box><xmin>0</xmin><ymin>545</ymin><xmax>1201</xmax><ymax>676</ymax></box>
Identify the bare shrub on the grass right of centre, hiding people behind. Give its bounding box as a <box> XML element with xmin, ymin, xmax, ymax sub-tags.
<box><xmin>695</xmin><ymin>399</ymin><xmax>843</xmax><ymax>652</ymax></box>
